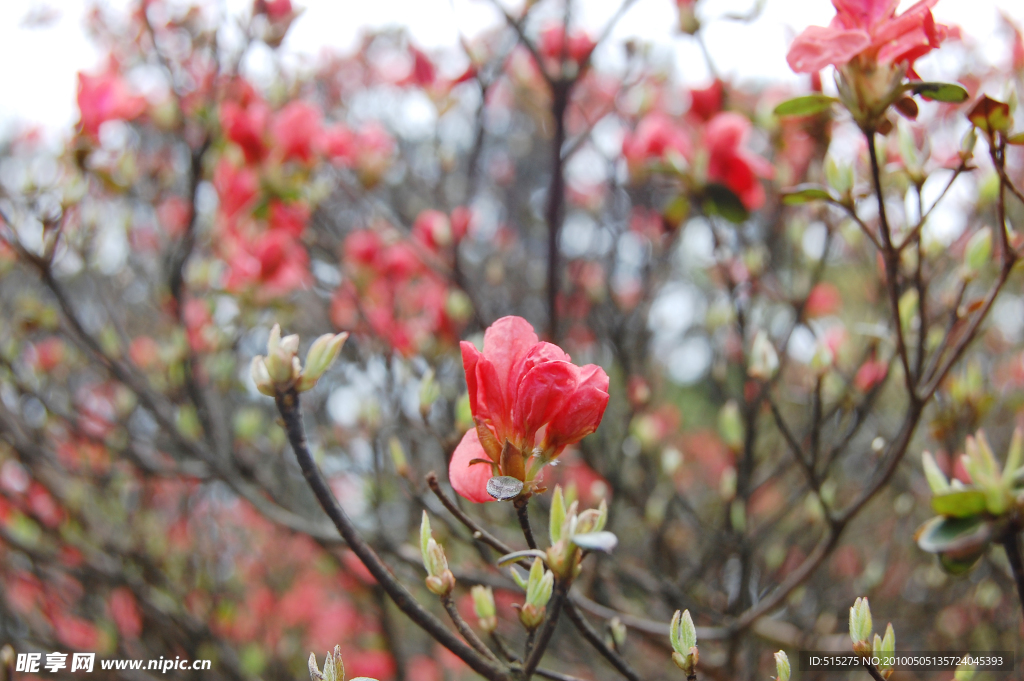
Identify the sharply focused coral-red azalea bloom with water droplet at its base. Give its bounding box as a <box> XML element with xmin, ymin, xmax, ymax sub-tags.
<box><xmin>449</xmin><ymin>316</ymin><xmax>608</xmax><ymax>502</ymax></box>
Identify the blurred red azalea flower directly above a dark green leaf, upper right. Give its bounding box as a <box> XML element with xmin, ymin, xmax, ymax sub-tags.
<box><xmin>705</xmin><ymin>112</ymin><xmax>774</xmax><ymax>210</ymax></box>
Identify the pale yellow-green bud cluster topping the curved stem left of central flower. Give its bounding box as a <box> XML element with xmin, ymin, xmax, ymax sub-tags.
<box><xmin>251</xmin><ymin>324</ymin><xmax>348</xmax><ymax>397</ymax></box>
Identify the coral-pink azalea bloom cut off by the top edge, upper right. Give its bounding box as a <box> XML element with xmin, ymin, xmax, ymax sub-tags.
<box><xmin>785</xmin><ymin>0</ymin><xmax>949</xmax><ymax>75</ymax></box>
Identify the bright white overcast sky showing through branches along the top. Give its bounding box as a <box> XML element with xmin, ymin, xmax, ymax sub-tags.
<box><xmin>0</xmin><ymin>0</ymin><xmax>1024</xmax><ymax>134</ymax></box>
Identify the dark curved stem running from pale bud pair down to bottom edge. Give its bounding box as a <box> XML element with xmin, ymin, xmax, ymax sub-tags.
<box><xmin>274</xmin><ymin>389</ymin><xmax>511</xmax><ymax>681</ymax></box>
